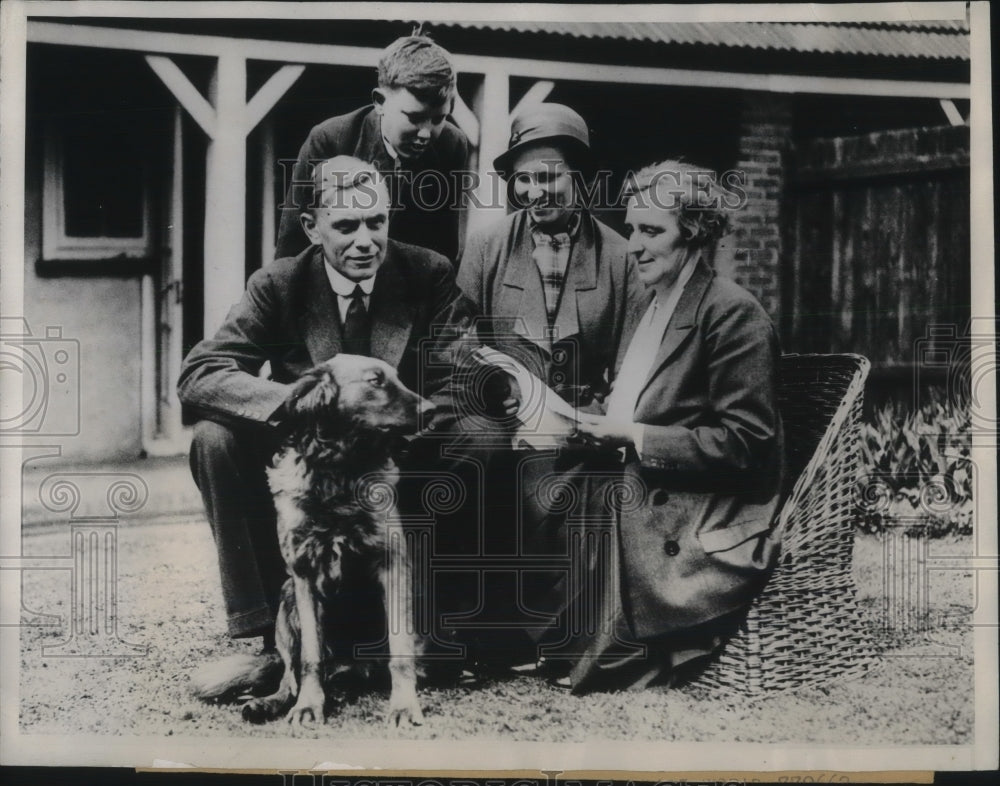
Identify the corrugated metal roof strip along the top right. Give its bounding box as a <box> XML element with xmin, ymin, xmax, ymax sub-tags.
<box><xmin>432</xmin><ymin>20</ymin><xmax>969</xmax><ymax>60</ymax></box>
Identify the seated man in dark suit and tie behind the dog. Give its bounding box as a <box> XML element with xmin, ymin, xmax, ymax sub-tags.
<box><xmin>178</xmin><ymin>156</ymin><xmax>472</xmax><ymax>647</ymax></box>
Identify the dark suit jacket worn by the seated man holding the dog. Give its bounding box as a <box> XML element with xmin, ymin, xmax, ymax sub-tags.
<box><xmin>177</xmin><ymin>240</ymin><xmax>472</xmax><ymax>429</ymax></box>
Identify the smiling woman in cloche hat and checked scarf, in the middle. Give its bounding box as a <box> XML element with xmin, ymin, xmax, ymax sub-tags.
<box><xmin>458</xmin><ymin>103</ymin><xmax>647</xmax><ymax>666</ymax></box>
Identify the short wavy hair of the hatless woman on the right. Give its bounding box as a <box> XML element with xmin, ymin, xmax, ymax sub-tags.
<box><xmin>626</xmin><ymin>159</ymin><xmax>730</xmax><ymax>248</ymax></box>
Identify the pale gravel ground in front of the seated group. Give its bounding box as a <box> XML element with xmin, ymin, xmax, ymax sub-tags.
<box><xmin>20</xmin><ymin>520</ymin><xmax>974</xmax><ymax>745</ymax></box>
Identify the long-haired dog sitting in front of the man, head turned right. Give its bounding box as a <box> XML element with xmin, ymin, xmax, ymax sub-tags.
<box><xmin>193</xmin><ymin>355</ymin><xmax>434</xmax><ymax>725</ymax></box>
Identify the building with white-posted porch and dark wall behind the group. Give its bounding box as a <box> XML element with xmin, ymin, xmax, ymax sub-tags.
<box><xmin>17</xmin><ymin>19</ymin><xmax>970</xmax><ymax>461</ymax></box>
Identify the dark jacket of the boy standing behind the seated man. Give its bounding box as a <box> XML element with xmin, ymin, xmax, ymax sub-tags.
<box><xmin>274</xmin><ymin>105</ymin><xmax>469</xmax><ymax>262</ymax></box>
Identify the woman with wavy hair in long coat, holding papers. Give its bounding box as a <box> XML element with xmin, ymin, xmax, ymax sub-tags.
<box><xmin>552</xmin><ymin>161</ymin><xmax>783</xmax><ymax>692</ymax></box>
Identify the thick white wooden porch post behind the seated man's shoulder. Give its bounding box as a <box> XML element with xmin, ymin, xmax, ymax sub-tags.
<box><xmin>204</xmin><ymin>52</ymin><xmax>247</xmax><ymax>336</ymax></box>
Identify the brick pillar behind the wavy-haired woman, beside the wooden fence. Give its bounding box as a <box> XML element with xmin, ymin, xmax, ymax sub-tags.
<box><xmin>717</xmin><ymin>92</ymin><xmax>792</xmax><ymax>324</ymax></box>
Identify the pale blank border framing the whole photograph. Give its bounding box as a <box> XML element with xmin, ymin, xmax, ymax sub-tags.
<box><xmin>0</xmin><ymin>0</ymin><xmax>998</xmax><ymax>779</ymax></box>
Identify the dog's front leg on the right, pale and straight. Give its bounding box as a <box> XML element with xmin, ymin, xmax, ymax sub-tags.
<box><xmin>380</xmin><ymin>522</ymin><xmax>424</xmax><ymax>726</ymax></box>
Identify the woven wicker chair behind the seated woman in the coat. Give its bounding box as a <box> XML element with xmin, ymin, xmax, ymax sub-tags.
<box><xmin>695</xmin><ymin>355</ymin><xmax>875</xmax><ymax>695</ymax></box>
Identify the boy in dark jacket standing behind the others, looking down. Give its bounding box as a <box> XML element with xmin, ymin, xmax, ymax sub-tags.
<box><xmin>275</xmin><ymin>36</ymin><xmax>469</xmax><ymax>262</ymax></box>
